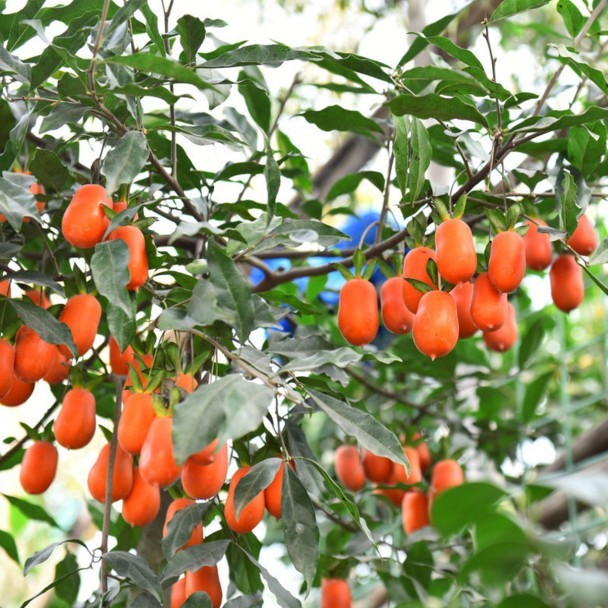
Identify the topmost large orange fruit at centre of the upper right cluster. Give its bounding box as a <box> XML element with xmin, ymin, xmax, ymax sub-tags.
<box><xmin>435</xmin><ymin>219</ymin><xmax>477</xmax><ymax>285</ymax></box>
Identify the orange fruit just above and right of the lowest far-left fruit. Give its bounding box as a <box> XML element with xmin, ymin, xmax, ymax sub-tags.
<box><xmin>53</xmin><ymin>387</ymin><xmax>95</xmax><ymax>450</ymax></box>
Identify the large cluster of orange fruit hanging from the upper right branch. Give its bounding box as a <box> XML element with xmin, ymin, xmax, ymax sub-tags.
<box><xmin>338</xmin><ymin>214</ymin><xmax>598</xmax><ymax>359</ymax></box>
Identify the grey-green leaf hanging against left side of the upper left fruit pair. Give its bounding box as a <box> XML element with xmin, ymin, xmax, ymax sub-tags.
<box><xmin>91</xmin><ymin>239</ymin><xmax>133</xmax><ymax>318</ymax></box>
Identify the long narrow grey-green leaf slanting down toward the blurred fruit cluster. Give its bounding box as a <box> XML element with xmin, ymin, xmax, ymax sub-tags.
<box><xmin>309</xmin><ymin>390</ymin><xmax>409</xmax><ymax>472</ymax></box>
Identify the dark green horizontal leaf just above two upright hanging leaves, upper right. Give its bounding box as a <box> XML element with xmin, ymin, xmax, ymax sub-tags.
<box><xmin>389</xmin><ymin>93</ymin><xmax>488</xmax><ymax>126</ymax></box>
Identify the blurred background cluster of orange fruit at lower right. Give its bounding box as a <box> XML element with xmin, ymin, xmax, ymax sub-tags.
<box><xmin>335</xmin><ymin>435</ymin><xmax>464</xmax><ymax>534</ymax></box>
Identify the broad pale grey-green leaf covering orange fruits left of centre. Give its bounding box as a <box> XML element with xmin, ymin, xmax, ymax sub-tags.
<box><xmin>173</xmin><ymin>374</ymin><xmax>274</xmax><ymax>462</ymax></box>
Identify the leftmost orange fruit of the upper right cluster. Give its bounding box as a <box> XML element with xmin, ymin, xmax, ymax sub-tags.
<box><xmin>338</xmin><ymin>279</ymin><xmax>380</xmax><ymax>346</ymax></box>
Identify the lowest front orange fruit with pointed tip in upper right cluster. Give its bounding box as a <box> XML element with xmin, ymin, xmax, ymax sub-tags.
<box><xmin>412</xmin><ymin>291</ymin><xmax>458</xmax><ymax>361</ymax></box>
